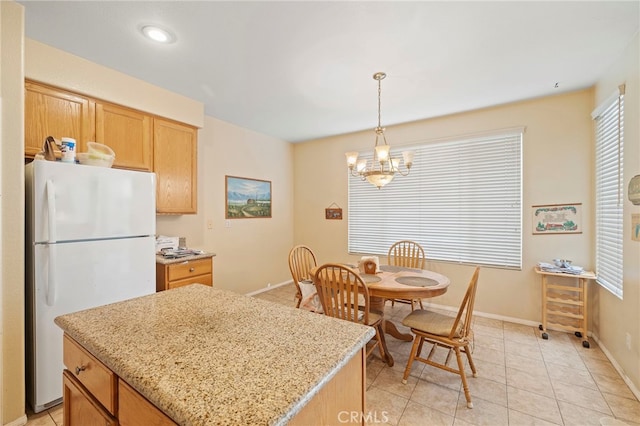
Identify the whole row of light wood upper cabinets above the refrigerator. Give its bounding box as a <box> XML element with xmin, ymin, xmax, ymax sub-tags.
<box><xmin>25</xmin><ymin>80</ymin><xmax>198</xmax><ymax>214</ymax></box>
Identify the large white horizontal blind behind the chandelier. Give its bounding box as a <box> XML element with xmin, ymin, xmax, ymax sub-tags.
<box><xmin>349</xmin><ymin>128</ymin><xmax>524</xmax><ymax>269</ymax></box>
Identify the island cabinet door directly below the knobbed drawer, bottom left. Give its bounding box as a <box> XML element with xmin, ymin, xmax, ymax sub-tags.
<box><xmin>62</xmin><ymin>370</ymin><xmax>118</xmax><ymax>426</ymax></box>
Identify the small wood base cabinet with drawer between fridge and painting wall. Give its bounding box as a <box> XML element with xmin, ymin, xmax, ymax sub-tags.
<box><xmin>156</xmin><ymin>257</ymin><xmax>213</xmax><ymax>291</ymax></box>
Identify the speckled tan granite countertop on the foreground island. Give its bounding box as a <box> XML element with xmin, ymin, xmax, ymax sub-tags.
<box><xmin>55</xmin><ymin>284</ymin><xmax>375</xmax><ymax>425</ymax></box>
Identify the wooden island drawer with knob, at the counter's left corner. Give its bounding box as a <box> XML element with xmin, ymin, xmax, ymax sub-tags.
<box><xmin>63</xmin><ymin>334</ymin><xmax>117</xmax><ymax>414</ymax></box>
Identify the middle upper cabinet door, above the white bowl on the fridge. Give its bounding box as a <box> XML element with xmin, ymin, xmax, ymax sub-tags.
<box><xmin>96</xmin><ymin>102</ymin><xmax>153</xmax><ymax>171</ymax></box>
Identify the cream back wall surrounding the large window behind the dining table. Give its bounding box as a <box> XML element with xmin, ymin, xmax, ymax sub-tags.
<box><xmin>294</xmin><ymin>90</ymin><xmax>593</xmax><ymax>323</ymax></box>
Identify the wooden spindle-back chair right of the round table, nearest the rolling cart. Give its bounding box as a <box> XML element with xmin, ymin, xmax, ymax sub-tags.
<box><xmin>402</xmin><ymin>267</ymin><xmax>480</xmax><ymax>408</ymax></box>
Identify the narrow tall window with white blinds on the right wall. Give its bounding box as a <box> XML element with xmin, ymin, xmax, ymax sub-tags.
<box><xmin>591</xmin><ymin>86</ymin><xmax>624</xmax><ymax>299</ymax></box>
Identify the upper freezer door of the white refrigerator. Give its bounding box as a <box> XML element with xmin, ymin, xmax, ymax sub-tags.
<box><xmin>25</xmin><ymin>161</ymin><xmax>156</xmax><ymax>242</ymax></box>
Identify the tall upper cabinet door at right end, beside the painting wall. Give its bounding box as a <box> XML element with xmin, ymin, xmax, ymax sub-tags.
<box><xmin>153</xmin><ymin>118</ymin><xmax>198</xmax><ymax>214</ymax></box>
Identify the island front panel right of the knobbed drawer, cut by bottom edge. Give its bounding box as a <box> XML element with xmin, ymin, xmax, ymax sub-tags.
<box><xmin>118</xmin><ymin>380</ymin><xmax>177</xmax><ymax>426</ymax></box>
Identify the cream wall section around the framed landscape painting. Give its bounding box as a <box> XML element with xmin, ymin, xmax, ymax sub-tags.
<box><xmin>157</xmin><ymin>117</ymin><xmax>293</xmax><ymax>294</ymax></box>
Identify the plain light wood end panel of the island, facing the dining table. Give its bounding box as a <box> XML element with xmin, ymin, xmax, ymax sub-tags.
<box><xmin>289</xmin><ymin>349</ymin><xmax>364</xmax><ymax>426</ymax></box>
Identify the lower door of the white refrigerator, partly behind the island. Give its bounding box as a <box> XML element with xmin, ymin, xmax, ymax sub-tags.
<box><xmin>27</xmin><ymin>236</ymin><xmax>156</xmax><ymax>412</ymax></box>
